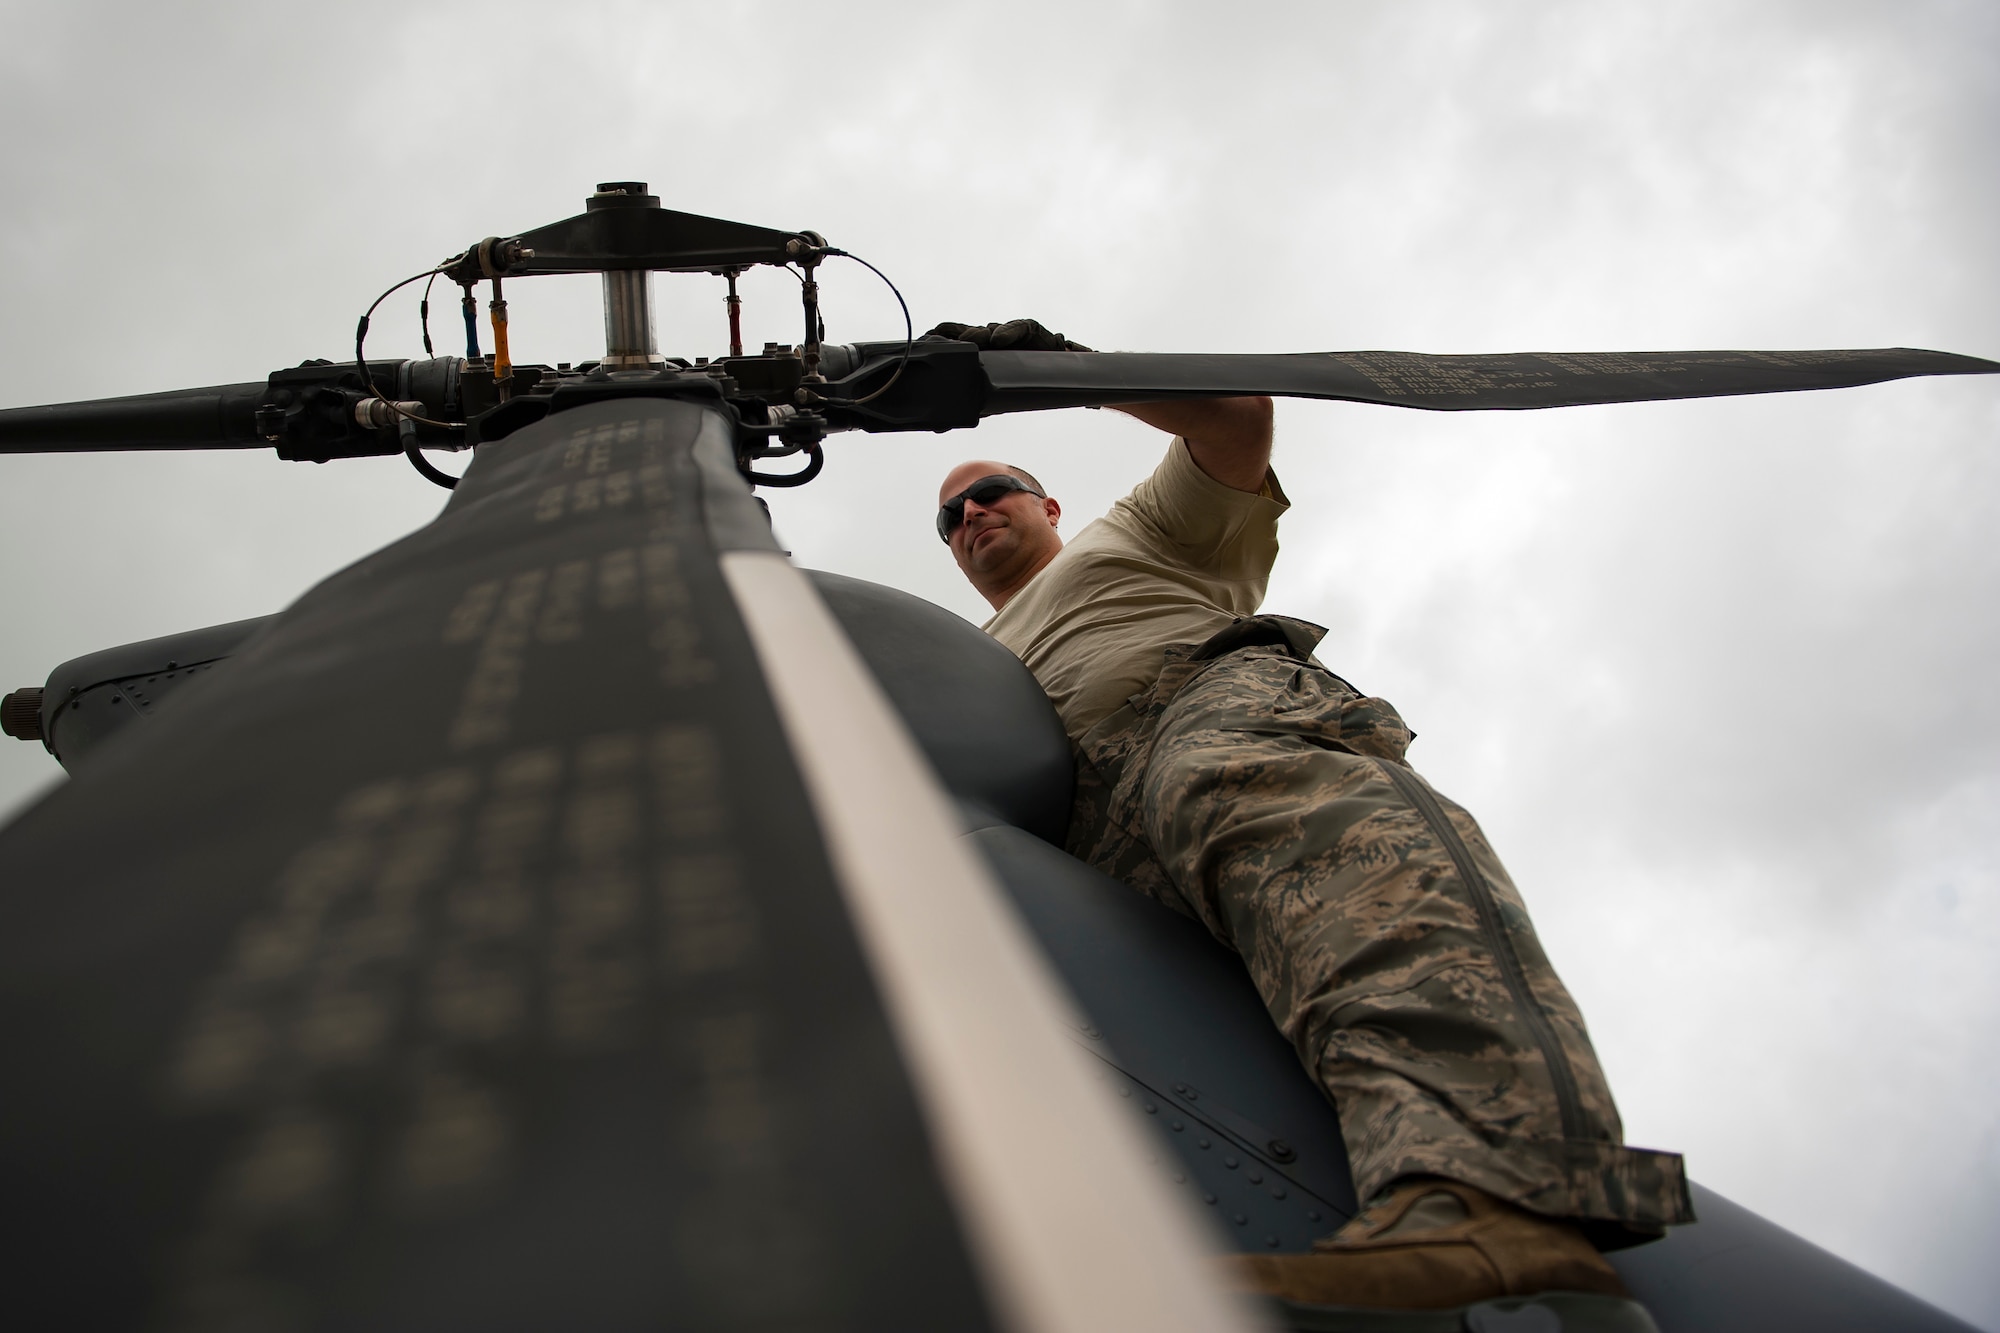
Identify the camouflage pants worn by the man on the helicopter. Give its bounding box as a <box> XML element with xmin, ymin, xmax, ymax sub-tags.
<box><xmin>1070</xmin><ymin>616</ymin><xmax>1694</xmax><ymax>1241</ymax></box>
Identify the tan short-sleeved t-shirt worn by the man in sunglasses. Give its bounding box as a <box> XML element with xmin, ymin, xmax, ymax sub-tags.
<box><xmin>980</xmin><ymin>436</ymin><xmax>1292</xmax><ymax>741</ymax></box>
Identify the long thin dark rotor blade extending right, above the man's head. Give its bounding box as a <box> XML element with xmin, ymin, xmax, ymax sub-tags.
<box><xmin>980</xmin><ymin>346</ymin><xmax>2000</xmax><ymax>416</ymax></box>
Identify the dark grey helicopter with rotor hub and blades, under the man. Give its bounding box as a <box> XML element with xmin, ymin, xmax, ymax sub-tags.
<box><xmin>0</xmin><ymin>182</ymin><xmax>2000</xmax><ymax>1329</ymax></box>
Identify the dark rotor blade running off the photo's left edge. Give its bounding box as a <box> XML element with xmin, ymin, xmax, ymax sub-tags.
<box><xmin>0</xmin><ymin>380</ymin><xmax>270</xmax><ymax>454</ymax></box>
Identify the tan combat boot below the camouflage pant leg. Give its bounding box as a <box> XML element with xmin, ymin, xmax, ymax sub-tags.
<box><xmin>1224</xmin><ymin>1181</ymin><xmax>1630</xmax><ymax>1311</ymax></box>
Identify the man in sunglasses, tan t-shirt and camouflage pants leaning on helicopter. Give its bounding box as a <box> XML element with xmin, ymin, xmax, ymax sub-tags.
<box><xmin>932</xmin><ymin>320</ymin><xmax>1694</xmax><ymax>1309</ymax></box>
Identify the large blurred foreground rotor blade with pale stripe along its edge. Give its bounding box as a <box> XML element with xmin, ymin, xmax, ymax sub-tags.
<box><xmin>0</xmin><ymin>388</ymin><xmax>1236</xmax><ymax>1333</ymax></box>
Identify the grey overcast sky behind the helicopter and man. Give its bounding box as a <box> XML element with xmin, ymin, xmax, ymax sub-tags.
<box><xmin>0</xmin><ymin>0</ymin><xmax>2000</xmax><ymax>1329</ymax></box>
